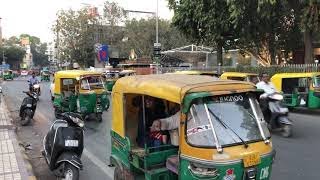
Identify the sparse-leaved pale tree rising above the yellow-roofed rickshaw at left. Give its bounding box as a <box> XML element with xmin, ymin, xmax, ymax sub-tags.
<box><xmin>53</xmin><ymin>9</ymin><xmax>97</xmax><ymax>66</ymax></box>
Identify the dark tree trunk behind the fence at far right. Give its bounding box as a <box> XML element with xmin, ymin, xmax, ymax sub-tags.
<box><xmin>304</xmin><ymin>29</ymin><xmax>314</xmax><ymax>64</ymax></box>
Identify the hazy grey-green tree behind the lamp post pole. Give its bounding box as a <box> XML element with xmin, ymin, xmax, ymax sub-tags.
<box><xmin>122</xmin><ymin>18</ymin><xmax>189</xmax><ymax>57</ymax></box>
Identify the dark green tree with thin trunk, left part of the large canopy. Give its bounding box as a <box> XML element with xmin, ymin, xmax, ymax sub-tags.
<box><xmin>168</xmin><ymin>0</ymin><xmax>236</xmax><ymax>64</ymax></box>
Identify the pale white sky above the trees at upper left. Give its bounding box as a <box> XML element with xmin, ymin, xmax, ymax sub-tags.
<box><xmin>0</xmin><ymin>0</ymin><xmax>173</xmax><ymax>42</ymax></box>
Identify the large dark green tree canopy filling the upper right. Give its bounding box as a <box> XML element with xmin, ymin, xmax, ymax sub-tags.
<box><xmin>168</xmin><ymin>0</ymin><xmax>320</xmax><ymax>66</ymax></box>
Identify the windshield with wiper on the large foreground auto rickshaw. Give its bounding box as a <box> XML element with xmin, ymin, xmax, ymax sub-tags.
<box><xmin>187</xmin><ymin>94</ymin><xmax>270</xmax><ymax>147</ymax></box>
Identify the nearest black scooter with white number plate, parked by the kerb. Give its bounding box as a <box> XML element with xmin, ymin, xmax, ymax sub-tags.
<box><xmin>42</xmin><ymin>112</ymin><xmax>84</xmax><ymax>180</ymax></box>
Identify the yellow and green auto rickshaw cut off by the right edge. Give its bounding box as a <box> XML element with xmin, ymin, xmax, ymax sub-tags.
<box><xmin>271</xmin><ymin>72</ymin><xmax>320</xmax><ymax>109</ymax></box>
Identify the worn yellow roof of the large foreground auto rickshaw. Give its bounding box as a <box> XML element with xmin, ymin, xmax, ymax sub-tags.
<box><xmin>112</xmin><ymin>74</ymin><xmax>256</xmax><ymax>104</ymax></box>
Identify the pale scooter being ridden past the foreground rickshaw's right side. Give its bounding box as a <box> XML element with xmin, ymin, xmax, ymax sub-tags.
<box><xmin>260</xmin><ymin>93</ymin><xmax>292</xmax><ymax>137</ymax></box>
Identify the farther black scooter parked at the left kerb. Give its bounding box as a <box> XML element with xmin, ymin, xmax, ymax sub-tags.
<box><xmin>19</xmin><ymin>91</ymin><xmax>38</xmax><ymax>126</ymax></box>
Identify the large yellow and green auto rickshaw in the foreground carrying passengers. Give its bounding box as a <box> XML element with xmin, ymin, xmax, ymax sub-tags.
<box><xmin>110</xmin><ymin>74</ymin><xmax>275</xmax><ymax>180</ymax></box>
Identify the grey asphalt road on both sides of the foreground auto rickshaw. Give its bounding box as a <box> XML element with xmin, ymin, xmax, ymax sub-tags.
<box><xmin>4</xmin><ymin>78</ymin><xmax>320</xmax><ymax>180</ymax></box>
